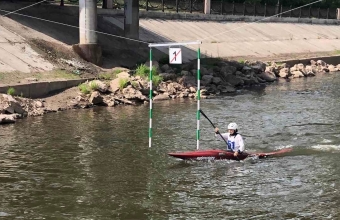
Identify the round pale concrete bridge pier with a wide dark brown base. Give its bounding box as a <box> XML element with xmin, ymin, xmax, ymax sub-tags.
<box><xmin>73</xmin><ymin>0</ymin><xmax>102</xmax><ymax>65</ymax></box>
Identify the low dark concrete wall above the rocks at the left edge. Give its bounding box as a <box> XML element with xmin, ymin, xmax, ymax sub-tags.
<box><xmin>0</xmin><ymin>79</ymin><xmax>91</xmax><ymax>98</ymax></box>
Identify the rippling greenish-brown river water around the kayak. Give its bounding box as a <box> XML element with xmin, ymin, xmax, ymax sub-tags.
<box><xmin>0</xmin><ymin>74</ymin><xmax>340</xmax><ymax>219</ymax></box>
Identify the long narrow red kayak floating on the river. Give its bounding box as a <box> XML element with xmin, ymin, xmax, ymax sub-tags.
<box><xmin>168</xmin><ymin>148</ymin><xmax>292</xmax><ymax>160</ymax></box>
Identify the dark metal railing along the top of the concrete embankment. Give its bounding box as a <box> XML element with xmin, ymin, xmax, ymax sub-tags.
<box><xmin>49</xmin><ymin>0</ymin><xmax>337</xmax><ymax>19</ymax></box>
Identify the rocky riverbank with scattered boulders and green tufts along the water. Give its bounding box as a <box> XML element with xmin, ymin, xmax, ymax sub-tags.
<box><xmin>0</xmin><ymin>59</ymin><xmax>340</xmax><ymax>124</ymax></box>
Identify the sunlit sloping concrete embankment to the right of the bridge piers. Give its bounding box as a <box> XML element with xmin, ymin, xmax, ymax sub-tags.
<box><xmin>132</xmin><ymin>19</ymin><xmax>340</xmax><ymax>59</ymax></box>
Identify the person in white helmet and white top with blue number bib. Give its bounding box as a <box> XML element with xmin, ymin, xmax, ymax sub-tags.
<box><xmin>215</xmin><ymin>122</ymin><xmax>244</xmax><ymax>157</ymax></box>
